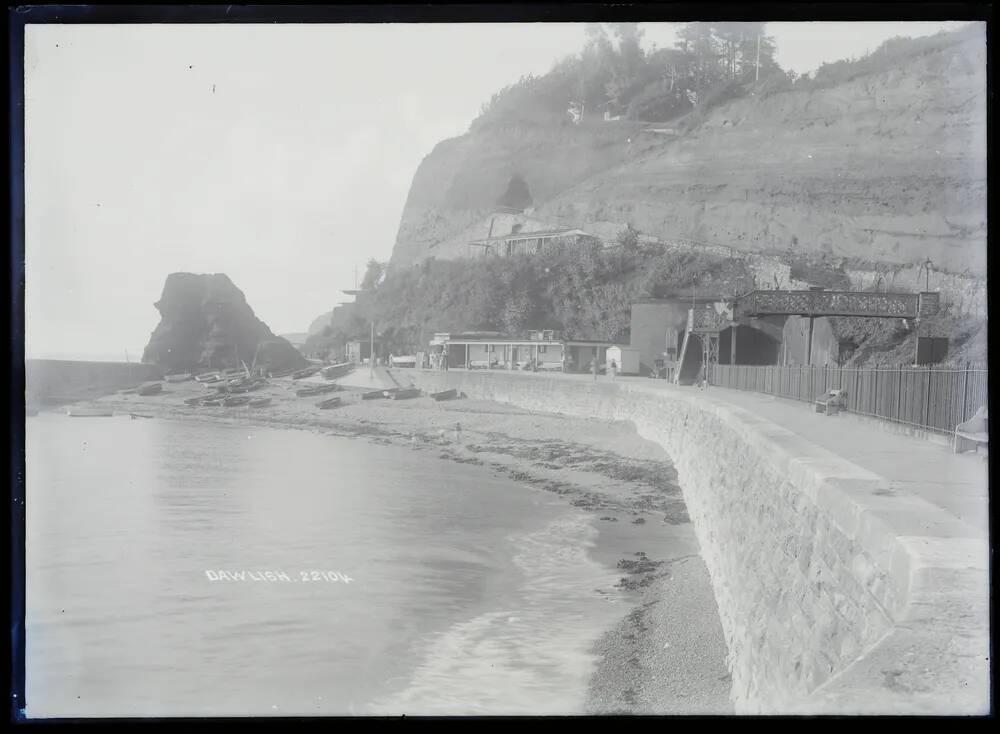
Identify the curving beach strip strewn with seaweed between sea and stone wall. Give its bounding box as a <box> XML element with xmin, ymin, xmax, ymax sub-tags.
<box><xmin>33</xmin><ymin>377</ymin><xmax>733</xmax><ymax>714</ymax></box>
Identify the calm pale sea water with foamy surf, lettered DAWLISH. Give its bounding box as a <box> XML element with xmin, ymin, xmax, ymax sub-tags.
<box><xmin>25</xmin><ymin>413</ymin><xmax>628</xmax><ymax>717</ymax></box>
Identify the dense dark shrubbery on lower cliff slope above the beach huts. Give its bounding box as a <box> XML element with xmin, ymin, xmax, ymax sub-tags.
<box><xmin>338</xmin><ymin>244</ymin><xmax>747</xmax><ymax>353</ymax></box>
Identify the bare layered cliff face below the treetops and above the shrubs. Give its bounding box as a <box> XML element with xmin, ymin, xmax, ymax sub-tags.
<box><xmin>393</xmin><ymin>28</ymin><xmax>986</xmax><ymax>274</ymax></box>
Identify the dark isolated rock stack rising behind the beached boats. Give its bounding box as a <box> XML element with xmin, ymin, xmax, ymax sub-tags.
<box><xmin>142</xmin><ymin>273</ymin><xmax>306</xmax><ymax>372</ymax></box>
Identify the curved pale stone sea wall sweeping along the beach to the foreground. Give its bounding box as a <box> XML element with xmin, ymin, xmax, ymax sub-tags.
<box><xmin>395</xmin><ymin>370</ymin><xmax>989</xmax><ymax>714</ymax></box>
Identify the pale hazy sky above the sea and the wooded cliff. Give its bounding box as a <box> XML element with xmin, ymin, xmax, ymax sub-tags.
<box><xmin>25</xmin><ymin>22</ymin><xmax>963</xmax><ymax>360</ymax></box>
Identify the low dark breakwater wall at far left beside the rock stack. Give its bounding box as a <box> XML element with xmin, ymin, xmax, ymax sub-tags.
<box><xmin>24</xmin><ymin>359</ymin><xmax>163</xmax><ymax>407</ymax></box>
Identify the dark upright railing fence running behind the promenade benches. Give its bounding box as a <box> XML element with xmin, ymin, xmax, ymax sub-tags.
<box><xmin>710</xmin><ymin>364</ymin><xmax>989</xmax><ymax>434</ymax></box>
